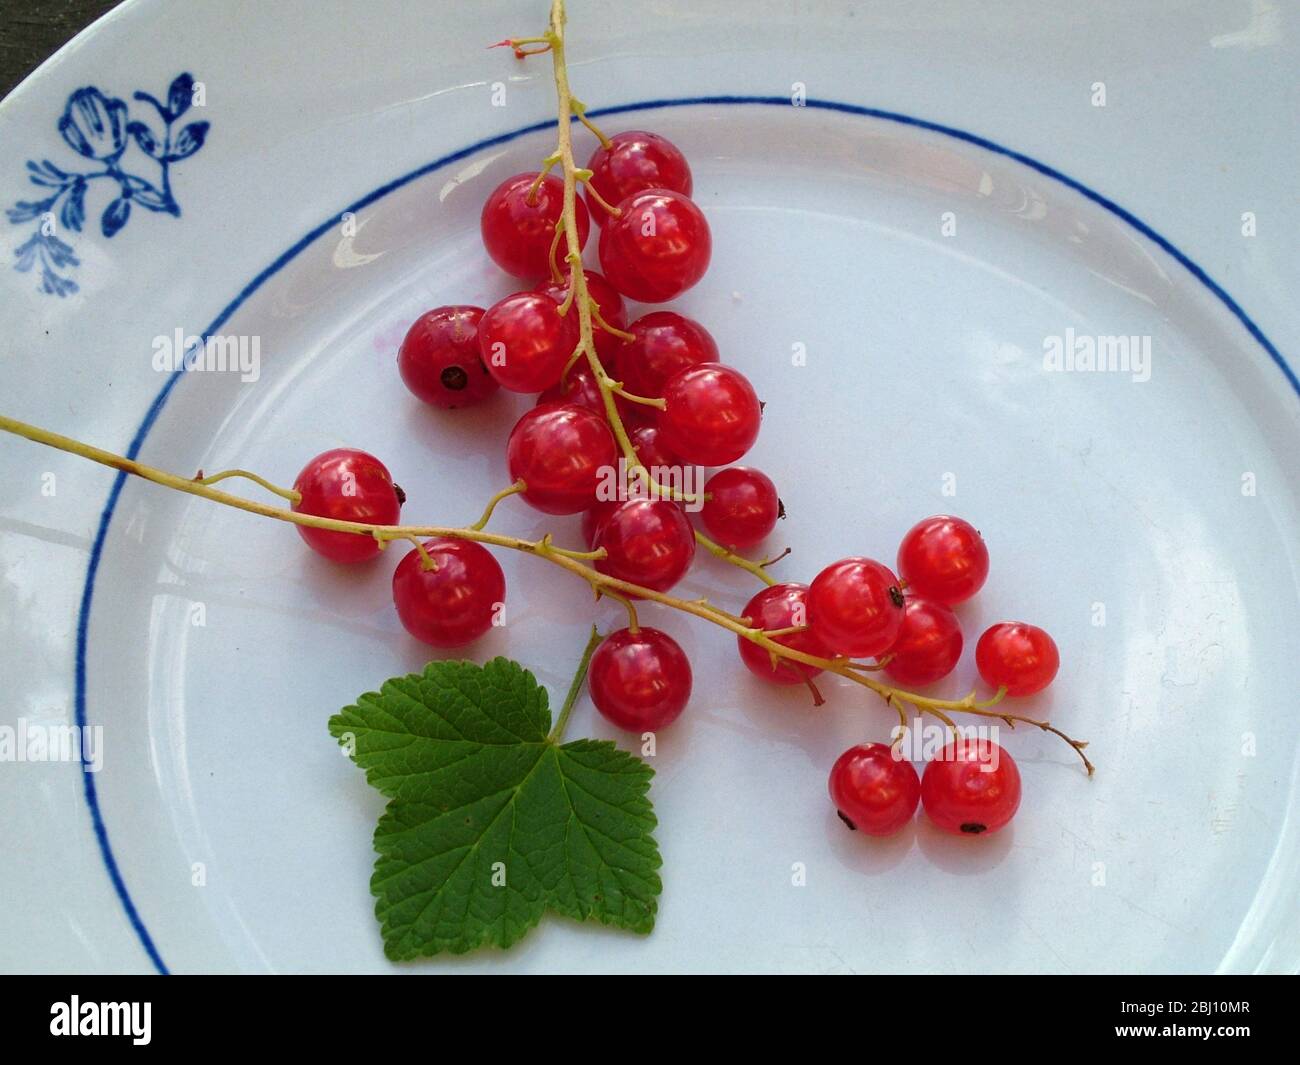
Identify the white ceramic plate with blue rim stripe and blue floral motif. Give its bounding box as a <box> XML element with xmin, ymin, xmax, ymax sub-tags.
<box><xmin>0</xmin><ymin>0</ymin><xmax>1300</xmax><ymax>973</ymax></box>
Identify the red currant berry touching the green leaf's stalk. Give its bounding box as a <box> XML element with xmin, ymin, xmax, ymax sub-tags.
<box><xmin>586</xmin><ymin>628</ymin><xmax>690</xmax><ymax>732</ymax></box>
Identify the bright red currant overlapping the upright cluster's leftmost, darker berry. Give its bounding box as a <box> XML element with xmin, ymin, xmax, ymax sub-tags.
<box><xmin>478</xmin><ymin>293</ymin><xmax>577</xmax><ymax>391</ymax></box>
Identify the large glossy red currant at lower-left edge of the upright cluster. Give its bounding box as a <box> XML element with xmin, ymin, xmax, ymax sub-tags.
<box><xmin>506</xmin><ymin>406</ymin><xmax>618</xmax><ymax>514</ymax></box>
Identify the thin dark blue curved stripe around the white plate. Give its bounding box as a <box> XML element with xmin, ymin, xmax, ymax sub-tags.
<box><xmin>75</xmin><ymin>96</ymin><xmax>1300</xmax><ymax>974</ymax></box>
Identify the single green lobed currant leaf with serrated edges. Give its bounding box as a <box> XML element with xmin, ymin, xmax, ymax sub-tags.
<box><xmin>329</xmin><ymin>658</ymin><xmax>662</xmax><ymax>961</ymax></box>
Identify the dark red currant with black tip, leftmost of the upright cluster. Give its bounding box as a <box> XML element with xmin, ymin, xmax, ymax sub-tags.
<box><xmin>398</xmin><ymin>307</ymin><xmax>497</xmax><ymax>411</ymax></box>
